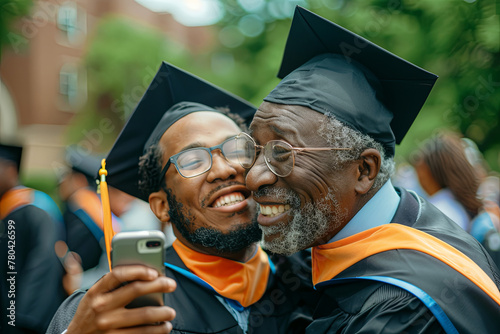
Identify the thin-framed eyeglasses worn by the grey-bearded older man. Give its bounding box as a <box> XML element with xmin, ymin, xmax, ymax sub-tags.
<box><xmin>236</xmin><ymin>132</ymin><xmax>351</xmax><ymax>177</ymax></box>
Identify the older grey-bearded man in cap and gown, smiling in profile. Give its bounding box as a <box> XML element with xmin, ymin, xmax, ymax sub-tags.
<box><xmin>238</xmin><ymin>8</ymin><xmax>500</xmax><ymax>334</ymax></box>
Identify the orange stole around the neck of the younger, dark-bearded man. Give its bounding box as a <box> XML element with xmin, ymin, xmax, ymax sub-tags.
<box><xmin>172</xmin><ymin>240</ymin><xmax>270</xmax><ymax>307</ymax></box>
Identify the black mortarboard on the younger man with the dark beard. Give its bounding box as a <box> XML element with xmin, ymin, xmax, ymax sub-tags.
<box><xmin>106</xmin><ymin>62</ymin><xmax>256</xmax><ymax>201</ymax></box>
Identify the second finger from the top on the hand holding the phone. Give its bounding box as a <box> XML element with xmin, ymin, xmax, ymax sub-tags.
<box><xmin>92</xmin><ymin>276</ymin><xmax>177</xmax><ymax>313</ymax></box>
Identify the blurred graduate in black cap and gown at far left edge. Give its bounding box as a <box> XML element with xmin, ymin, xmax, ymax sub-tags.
<box><xmin>0</xmin><ymin>144</ymin><xmax>66</xmax><ymax>333</ymax></box>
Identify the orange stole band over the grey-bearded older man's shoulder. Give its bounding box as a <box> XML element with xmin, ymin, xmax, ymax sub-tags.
<box><xmin>312</xmin><ymin>223</ymin><xmax>500</xmax><ymax>305</ymax></box>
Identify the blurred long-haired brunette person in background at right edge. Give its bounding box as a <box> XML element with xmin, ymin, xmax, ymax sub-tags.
<box><xmin>413</xmin><ymin>132</ymin><xmax>500</xmax><ymax>266</ymax></box>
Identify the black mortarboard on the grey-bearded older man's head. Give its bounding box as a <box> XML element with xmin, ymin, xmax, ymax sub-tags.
<box><xmin>264</xmin><ymin>6</ymin><xmax>437</xmax><ymax>156</ymax></box>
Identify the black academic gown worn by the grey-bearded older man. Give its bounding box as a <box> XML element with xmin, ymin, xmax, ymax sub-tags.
<box><xmin>306</xmin><ymin>189</ymin><xmax>500</xmax><ymax>334</ymax></box>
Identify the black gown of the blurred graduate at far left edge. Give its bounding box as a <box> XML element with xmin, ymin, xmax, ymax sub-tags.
<box><xmin>0</xmin><ymin>205</ymin><xmax>66</xmax><ymax>334</ymax></box>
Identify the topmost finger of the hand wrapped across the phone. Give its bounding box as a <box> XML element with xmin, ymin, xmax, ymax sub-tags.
<box><xmin>89</xmin><ymin>265</ymin><xmax>158</xmax><ymax>293</ymax></box>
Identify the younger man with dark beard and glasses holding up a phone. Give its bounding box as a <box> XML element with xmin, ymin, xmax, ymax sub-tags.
<box><xmin>49</xmin><ymin>63</ymin><xmax>308</xmax><ymax>334</ymax></box>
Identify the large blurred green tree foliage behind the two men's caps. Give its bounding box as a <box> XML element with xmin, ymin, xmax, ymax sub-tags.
<box><xmin>72</xmin><ymin>0</ymin><xmax>500</xmax><ymax>170</ymax></box>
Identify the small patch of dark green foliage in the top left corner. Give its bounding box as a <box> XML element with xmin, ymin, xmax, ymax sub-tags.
<box><xmin>0</xmin><ymin>0</ymin><xmax>33</xmax><ymax>59</ymax></box>
